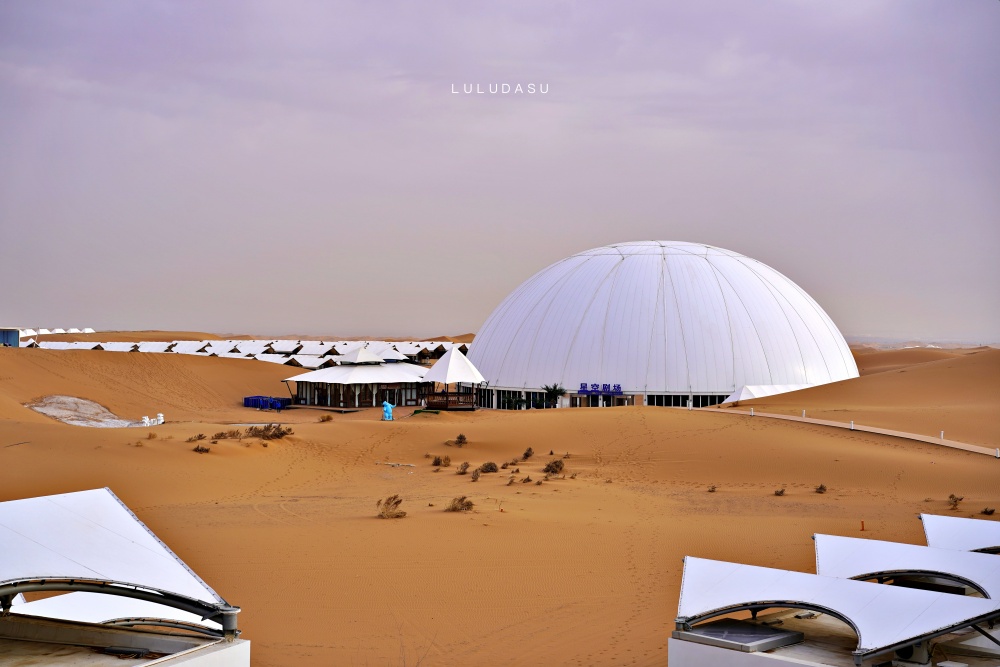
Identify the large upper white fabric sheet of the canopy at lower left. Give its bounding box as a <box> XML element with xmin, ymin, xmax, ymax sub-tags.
<box><xmin>0</xmin><ymin>488</ymin><xmax>224</xmax><ymax>604</ymax></box>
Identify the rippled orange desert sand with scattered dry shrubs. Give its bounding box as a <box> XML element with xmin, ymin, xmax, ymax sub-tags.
<box><xmin>0</xmin><ymin>349</ymin><xmax>1000</xmax><ymax>667</ymax></box>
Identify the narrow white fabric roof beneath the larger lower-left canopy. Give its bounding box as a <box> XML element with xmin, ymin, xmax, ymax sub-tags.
<box><xmin>12</xmin><ymin>591</ymin><xmax>219</xmax><ymax>627</ymax></box>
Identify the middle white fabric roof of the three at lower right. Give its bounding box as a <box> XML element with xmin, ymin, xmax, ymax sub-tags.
<box><xmin>813</xmin><ymin>535</ymin><xmax>1000</xmax><ymax>600</ymax></box>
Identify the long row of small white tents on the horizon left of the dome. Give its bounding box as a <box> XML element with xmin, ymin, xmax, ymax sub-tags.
<box><xmin>21</xmin><ymin>339</ymin><xmax>468</xmax><ymax>370</ymax></box>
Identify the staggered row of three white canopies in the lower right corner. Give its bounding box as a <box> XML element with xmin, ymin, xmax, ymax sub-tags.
<box><xmin>670</xmin><ymin>514</ymin><xmax>1000</xmax><ymax>667</ymax></box>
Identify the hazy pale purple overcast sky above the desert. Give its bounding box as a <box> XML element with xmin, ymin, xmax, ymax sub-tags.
<box><xmin>0</xmin><ymin>0</ymin><xmax>1000</xmax><ymax>342</ymax></box>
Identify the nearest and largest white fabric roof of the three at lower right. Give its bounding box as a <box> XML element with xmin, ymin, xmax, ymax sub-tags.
<box><xmin>677</xmin><ymin>556</ymin><xmax>1000</xmax><ymax>653</ymax></box>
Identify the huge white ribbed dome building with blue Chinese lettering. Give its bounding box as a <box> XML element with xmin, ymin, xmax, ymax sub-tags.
<box><xmin>469</xmin><ymin>241</ymin><xmax>858</xmax><ymax>408</ymax></box>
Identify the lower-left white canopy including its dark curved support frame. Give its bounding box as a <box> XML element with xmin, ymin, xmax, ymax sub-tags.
<box><xmin>0</xmin><ymin>488</ymin><xmax>239</xmax><ymax>634</ymax></box>
